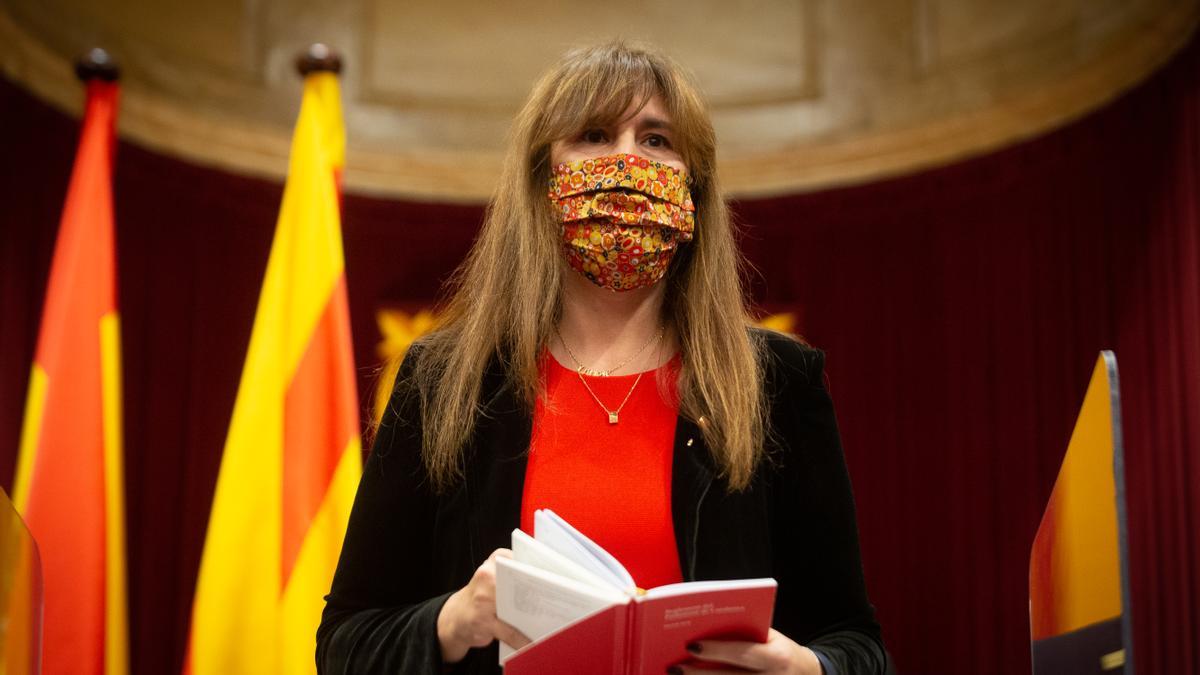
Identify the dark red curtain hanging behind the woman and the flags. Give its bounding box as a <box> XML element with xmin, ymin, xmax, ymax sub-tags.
<box><xmin>0</xmin><ymin>32</ymin><xmax>1200</xmax><ymax>674</ymax></box>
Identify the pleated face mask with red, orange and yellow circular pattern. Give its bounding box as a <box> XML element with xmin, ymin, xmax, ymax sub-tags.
<box><xmin>550</xmin><ymin>154</ymin><xmax>696</xmax><ymax>291</ymax></box>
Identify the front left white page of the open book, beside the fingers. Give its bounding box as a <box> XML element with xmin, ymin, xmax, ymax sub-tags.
<box><xmin>496</xmin><ymin>557</ymin><xmax>630</xmax><ymax>663</ymax></box>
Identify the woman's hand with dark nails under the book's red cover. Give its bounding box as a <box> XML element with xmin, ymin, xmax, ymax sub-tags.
<box><xmin>667</xmin><ymin>628</ymin><xmax>822</xmax><ymax>675</ymax></box>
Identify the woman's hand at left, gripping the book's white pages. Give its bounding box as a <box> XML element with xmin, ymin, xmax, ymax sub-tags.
<box><xmin>438</xmin><ymin>549</ymin><xmax>529</xmax><ymax>663</ymax></box>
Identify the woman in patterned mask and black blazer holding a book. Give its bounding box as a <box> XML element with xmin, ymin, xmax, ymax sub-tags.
<box><xmin>317</xmin><ymin>42</ymin><xmax>884</xmax><ymax>675</ymax></box>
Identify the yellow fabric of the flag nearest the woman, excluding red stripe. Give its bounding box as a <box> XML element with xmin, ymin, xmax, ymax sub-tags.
<box><xmin>190</xmin><ymin>73</ymin><xmax>361</xmax><ymax>675</ymax></box>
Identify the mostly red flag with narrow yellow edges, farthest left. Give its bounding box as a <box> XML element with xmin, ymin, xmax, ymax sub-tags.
<box><xmin>13</xmin><ymin>79</ymin><xmax>128</xmax><ymax>675</ymax></box>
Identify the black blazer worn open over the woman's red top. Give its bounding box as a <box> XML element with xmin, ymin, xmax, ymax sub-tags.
<box><xmin>317</xmin><ymin>331</ymin><xmax>886</xmax><ymax>675</ymax></box>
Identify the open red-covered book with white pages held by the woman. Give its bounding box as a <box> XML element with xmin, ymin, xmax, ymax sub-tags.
<box><xmin>496</xmin><ymin>509</ymin><xmax>775</xmax><ymax>675</ymax></box>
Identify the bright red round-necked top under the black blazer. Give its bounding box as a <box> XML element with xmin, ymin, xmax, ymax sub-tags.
<box><xmin>521</xmin><ymin>353</ymin><xmax>683</xmax><ymax>589</ymax></box>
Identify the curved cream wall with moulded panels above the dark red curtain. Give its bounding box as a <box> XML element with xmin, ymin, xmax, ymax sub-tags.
<box><xmin>0</xmin><ymin>0</ymin><xmax>1200</xmax><ymax>202</ymax></box>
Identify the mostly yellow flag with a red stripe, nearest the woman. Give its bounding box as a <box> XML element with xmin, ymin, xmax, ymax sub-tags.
<box><xmin>184</xmin><ymin>72</ymin><xmax>362</xmax><ymax>675</ymax></box>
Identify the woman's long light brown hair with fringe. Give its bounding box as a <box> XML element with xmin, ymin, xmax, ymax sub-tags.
<box><xmin>413</xmin><ymin>41</ymin><xmax>764</xmax><ymax>490</ymax></box>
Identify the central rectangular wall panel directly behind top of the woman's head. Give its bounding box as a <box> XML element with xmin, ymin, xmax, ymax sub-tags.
<box><xmin>362</xmin><ymin>0</ymin><xmax>816</xmax><ymax>110</ymax></box>
